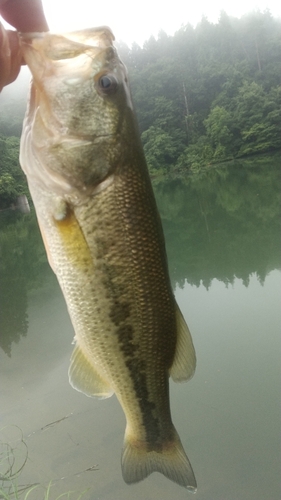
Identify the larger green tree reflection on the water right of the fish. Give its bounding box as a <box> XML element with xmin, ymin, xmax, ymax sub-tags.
<box><xmin>155</xmin><ymin>159</ymin><xmax>281</xmax><ymax>288</ymax></box>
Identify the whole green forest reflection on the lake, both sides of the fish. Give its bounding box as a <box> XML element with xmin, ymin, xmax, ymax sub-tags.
<box><xmin>0</xmin><ymin>158</ymin><xmax>281</xmax><ymax>356</ymax></box>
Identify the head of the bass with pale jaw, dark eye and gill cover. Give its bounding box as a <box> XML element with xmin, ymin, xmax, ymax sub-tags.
<box><xmin>21</xmin><ymin>28</ymin><xmax>135</xmax><ymax>194</ymax></box>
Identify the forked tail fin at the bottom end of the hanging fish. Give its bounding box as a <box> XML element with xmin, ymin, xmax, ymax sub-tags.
<box><xmin>121</xmin><ymin>430</ymin><xmax>197</xmax><ymax>493</ymax></box>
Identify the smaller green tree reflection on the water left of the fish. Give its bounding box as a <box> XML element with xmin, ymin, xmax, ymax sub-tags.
<box><xmin>0</xmin><ymin>211</ymin><xmax>47</xmax><ymax>356</ymax></box>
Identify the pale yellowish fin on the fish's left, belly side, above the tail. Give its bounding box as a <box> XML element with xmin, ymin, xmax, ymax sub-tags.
<box><xmin>68</xmin><ymin>345</ymin><xmax>113</xmax><ymax>399</ymax></box>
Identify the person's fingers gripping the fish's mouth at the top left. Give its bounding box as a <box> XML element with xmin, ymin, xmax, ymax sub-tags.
<box><xmin>0</xmin><ymin>0</ymin><xmax>49</xmax><ymax>91</ymax></box>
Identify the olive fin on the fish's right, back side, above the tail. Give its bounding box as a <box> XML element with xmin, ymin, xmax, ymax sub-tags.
<box><xmin>167</xmin><ymin>303</ymin><xmax>196</xmax><ymax>382</ymax></box>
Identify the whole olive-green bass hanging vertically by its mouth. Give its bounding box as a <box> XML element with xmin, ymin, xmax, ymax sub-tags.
<box><xmin>20</xmin><ymin>27</ymin><xmax>197</xmax><ymax>492</ymax></box>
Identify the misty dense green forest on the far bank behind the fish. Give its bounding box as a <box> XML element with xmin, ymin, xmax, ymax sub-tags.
<box><xmin>0</xmin><ymin>11</ymin><xmax>281</xmax><ymax>208</ymax></box>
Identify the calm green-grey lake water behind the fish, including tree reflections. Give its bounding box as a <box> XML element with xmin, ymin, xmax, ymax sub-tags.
<box><xmin>0</xmin><ymin>161</ymin><xmax>281</xmax><ymax>500</ymax></box>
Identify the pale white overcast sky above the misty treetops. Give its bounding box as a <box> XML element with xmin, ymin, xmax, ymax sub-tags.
<box><xmin>0</xmin><ymin>0</ymin><xmax>281</xmax><ymax>46</ymax></box>
